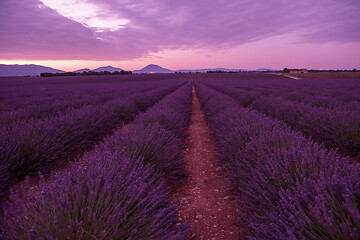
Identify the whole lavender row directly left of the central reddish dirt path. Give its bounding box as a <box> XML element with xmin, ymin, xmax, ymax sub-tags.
<box><xmin>0</xmin><ymin>83</ymin><xmax>191</xmax><ymax>240</ymax></box>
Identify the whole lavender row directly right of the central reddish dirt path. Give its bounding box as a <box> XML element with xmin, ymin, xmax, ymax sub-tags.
<box><xmin>196</xmin><ymin>83</ymin><xmax>360</xmax><ymax>239</ymax></box>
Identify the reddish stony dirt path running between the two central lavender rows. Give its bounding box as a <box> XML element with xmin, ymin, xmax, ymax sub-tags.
<box><xmin>174</xmin><ymin>85</ymin><xmax>240</xmax><ymax>240</ymax></box>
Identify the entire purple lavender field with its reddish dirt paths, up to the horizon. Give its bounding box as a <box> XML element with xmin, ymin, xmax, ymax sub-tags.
<box><xmin>0</xmin><ymin>72</ymin><xmax>360</xmax><ymax>240</ymax></box>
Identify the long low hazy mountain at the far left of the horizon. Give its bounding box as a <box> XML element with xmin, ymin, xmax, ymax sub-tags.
<box><xmin>0</xmin><ymin>64</ymin><xmax>64</xmax><ymax>77</ymax></box>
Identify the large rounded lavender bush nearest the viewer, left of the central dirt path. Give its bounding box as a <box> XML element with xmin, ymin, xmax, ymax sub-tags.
<box><xmin>1</xmin><ymin>152</ymin><xmax>186</xmax><ymax>239</ymax></box>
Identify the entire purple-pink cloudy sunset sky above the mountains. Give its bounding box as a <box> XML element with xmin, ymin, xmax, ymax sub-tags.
<box><xmin>0</xmin><ymin>0</ymin><xmax>360</xmax><ymax>71</ymax></box>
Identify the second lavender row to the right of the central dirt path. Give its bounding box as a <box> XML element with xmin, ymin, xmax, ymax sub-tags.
<box><xmin>202</xmin><ymin>83</ymin><xmax>360</xmax><ymax>157</ymax></box>
